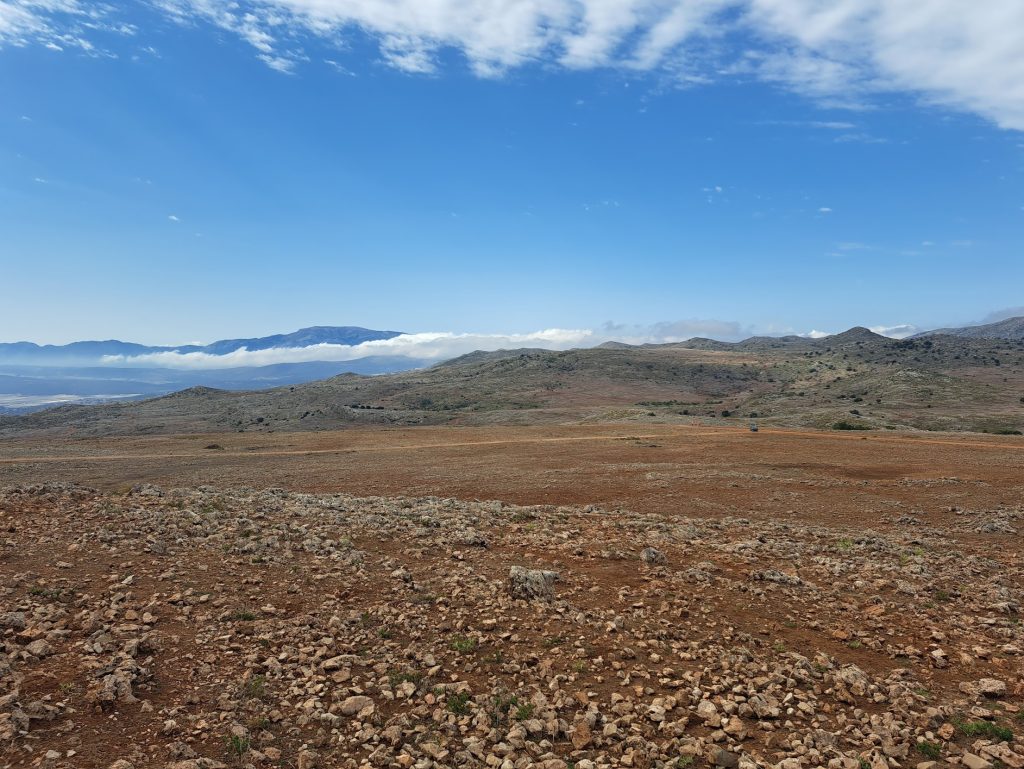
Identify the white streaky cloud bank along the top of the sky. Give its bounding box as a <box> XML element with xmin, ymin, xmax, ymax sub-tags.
<box><xmin>6</xmin><ymin>0</ymin><xmax>1024</xmax><ymax>130</ymax></box>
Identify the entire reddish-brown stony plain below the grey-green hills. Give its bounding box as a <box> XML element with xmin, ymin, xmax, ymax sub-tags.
<box><xmin>0</xmin><ymin>424</ymin><xmax>1024</xmax><ymax>769</ymax></box>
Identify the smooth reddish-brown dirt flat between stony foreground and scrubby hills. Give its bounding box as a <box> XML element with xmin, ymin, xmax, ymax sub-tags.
<box><xmin>0</xmin><ymin>425</ymin><xmax>1024</xmax><ymax>524</ymax></box>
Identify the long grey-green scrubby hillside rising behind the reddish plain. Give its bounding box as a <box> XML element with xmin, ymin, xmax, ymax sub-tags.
<box><xmin>0</xmin><ymin>329</ymin><xmax>1024</xmax><ymax>435</ymax></box>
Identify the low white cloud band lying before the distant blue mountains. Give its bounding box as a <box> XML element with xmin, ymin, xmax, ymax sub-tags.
<box><xmin>102</xmin><ymin>319</ymin><xmax>912</xmax><ymax>371</ymax></box>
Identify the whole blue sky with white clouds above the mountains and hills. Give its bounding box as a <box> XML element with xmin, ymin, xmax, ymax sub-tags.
<box><xmin>0</xmin><ymin>0</ymin><xmax>1024</xmax><ymax>343</ymax></box>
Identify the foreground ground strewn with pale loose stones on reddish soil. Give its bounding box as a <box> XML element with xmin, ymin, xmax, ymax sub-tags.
<box><xmin>0</xmin><ymin>484</ymin><xmax>1024</xmax><ymax>769</ymax></box>
